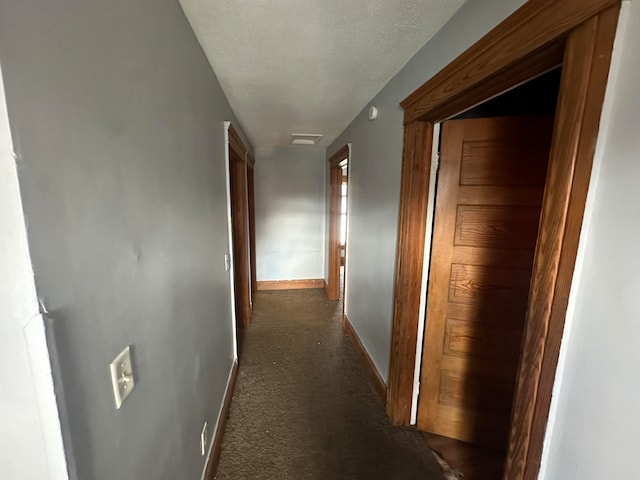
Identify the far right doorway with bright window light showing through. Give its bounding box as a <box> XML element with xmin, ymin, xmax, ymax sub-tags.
<box><xmin>326</xmin><ymin>145</ymin><xmax>349</xmax><ymax>300</ymax></box>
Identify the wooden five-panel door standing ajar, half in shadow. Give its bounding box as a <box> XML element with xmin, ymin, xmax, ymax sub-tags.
<box><xmin>418</xmin><ymin>117</ymin><xmax>553</xmax><ymax>449</ymax></box>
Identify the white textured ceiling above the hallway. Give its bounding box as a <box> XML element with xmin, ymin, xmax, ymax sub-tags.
<box><xmin>180</xmin><ymin>0</ymin><xmax>464</xmax><ymax>147</ymax></box>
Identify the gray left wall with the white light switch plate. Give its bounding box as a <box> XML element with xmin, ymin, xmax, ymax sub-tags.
<box><xmin>0</xmin><ymin>0</ymin><xmax>238</xmax><ymax>480</ymax></box>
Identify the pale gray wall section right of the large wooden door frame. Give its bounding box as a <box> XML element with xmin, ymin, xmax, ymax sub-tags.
<box><xmin>540</xmin><ymin>0</ymin><xmax>640</xmax><ymax>480</ymax></box>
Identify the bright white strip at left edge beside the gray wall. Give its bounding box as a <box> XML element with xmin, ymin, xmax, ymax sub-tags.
<box><xmin>0</xmin><ymin>65</ymin><xmax>68</xmax><ymax>480</ymax></box>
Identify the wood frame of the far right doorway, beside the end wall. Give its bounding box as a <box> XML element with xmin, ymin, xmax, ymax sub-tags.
<box><xmin>326</xmin><ymin>145</ymin><xmax>349</xmax><ymax>300</ymax></box>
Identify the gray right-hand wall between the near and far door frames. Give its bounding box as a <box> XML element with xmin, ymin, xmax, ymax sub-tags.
<box><xmin>327</xmin><ymin>0</ymin><xmax>524</xmax><ymax>379</ymax></box>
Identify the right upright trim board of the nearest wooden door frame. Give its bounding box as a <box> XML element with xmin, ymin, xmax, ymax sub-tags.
<box><xmin>506</xmin><ymin>7</ymin><xmax>619</xmax><ymax>479</ymax></box>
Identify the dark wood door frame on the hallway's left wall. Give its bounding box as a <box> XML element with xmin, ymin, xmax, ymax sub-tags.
<box><xmin>228</xmin><ymin>125</ymin><xmax>251</xmax><ymax>325</ymax></box>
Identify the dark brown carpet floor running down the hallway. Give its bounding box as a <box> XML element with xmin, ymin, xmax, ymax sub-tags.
<box><xmin>215</xmin><ymin>290</ymin><xmax>443</xmax><ymax>480</ymax></box>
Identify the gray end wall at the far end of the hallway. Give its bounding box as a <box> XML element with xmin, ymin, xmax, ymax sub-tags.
<box><xmin>255</xmin><ymin>146</ymin><xmax>327</xmax><ymax>281</ymax></box>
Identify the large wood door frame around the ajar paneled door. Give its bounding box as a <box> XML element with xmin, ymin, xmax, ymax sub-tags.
<box><xmin>387</xmin><ymin>0</ymin><xmax>620</xmax><ymax>480</ymax></box>
